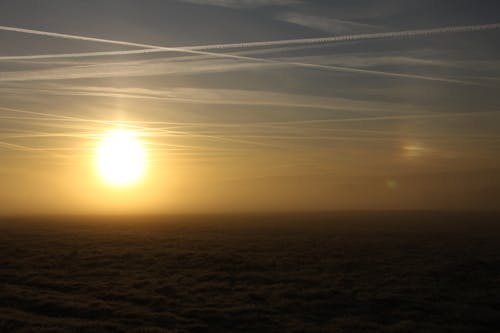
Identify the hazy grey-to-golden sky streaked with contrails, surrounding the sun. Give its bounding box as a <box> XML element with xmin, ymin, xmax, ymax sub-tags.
<box><xmin>0</xmin><ymin>0</ymin><xmax>500</xmax><ymax>214</ymax></box>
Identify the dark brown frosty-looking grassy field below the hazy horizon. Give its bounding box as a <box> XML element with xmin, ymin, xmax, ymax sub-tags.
<box><xmin>0</xmin><ymin>212</ymin><xmax>500</xmax><ymax>333</ymax></box>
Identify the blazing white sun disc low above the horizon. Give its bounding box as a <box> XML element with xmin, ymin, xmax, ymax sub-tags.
<box><xmin>96</xmin><ymin>130</ymin><xmax>146</xmax><ymax>187</ymax></box>
